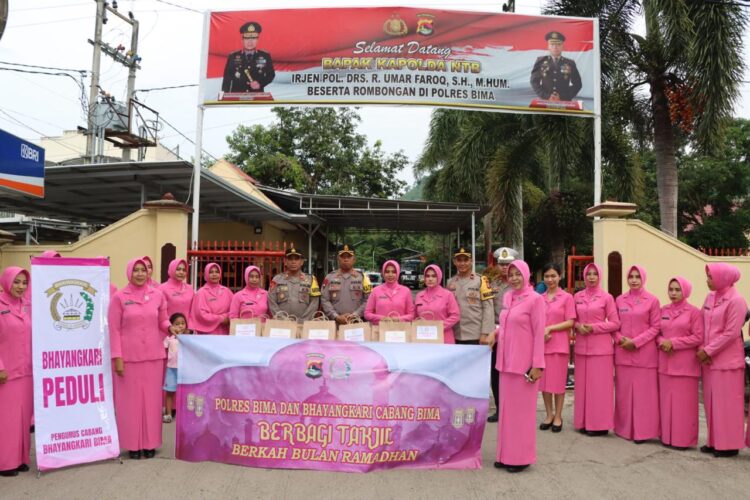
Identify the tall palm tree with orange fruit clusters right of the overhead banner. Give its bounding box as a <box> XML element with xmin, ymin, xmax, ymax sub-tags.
<box><xmin>547</xmin><ymin>0</ymin><xmax>747</xmax><ymax>236</ymax></box>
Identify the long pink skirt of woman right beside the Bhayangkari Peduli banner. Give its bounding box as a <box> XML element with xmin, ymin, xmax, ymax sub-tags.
<box><xmin>112</xmin><ymin>359</ymin><xmax>164</xmax><ymax>451</ymax></box>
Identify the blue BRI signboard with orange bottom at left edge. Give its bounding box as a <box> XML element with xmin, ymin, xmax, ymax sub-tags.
<box><xmin>0</xmin><ymin>130</ymin><xmax>44</xmax><ymax>198</ymax></box>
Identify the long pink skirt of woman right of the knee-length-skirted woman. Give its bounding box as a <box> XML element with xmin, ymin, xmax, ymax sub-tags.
<box><xmin>573</xmin><ymin>354</ymin><xmax>615</xmax><ymax>431</ymax></box>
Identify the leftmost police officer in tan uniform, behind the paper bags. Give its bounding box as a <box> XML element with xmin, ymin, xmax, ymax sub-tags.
<box><xmin>268</xmin><ymin>247</ymin><xmax>320</xmax><ymax>323</ymax></box>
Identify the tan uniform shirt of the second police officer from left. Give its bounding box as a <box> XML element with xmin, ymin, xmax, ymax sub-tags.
<box><xmin>320</xmin><ymin>269</ymin><xmax>372</xmax><ymax>319</ymax></box>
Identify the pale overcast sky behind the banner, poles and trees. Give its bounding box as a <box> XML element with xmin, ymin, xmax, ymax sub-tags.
<box><xmin>0</xmin><ymin>0</ymin><xmax>750</xmax><ymax>188</ymax></box>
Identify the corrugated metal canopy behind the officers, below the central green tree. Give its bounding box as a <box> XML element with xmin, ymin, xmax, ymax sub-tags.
<box><xmin>258</xmin><ymin>186</ymin><xmax>486</xmax><ymax>233</ymax></box>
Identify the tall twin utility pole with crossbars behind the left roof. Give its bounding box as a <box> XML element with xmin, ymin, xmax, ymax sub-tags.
<box><xmin>86</xmin><ymin>0</ymin><xmax>141</xmax><ymax>162</ymax></box>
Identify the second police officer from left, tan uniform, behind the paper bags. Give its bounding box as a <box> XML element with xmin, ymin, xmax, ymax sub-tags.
<box><xmin>320</xmin><ymin>245</ymin><xmax>372</xmax><ymax>325</ymax></box>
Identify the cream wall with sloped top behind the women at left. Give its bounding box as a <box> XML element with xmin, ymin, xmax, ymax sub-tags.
<box><xmin>0</xmin><ymin>208</ymin><xmax>188</xmax><ymax>288</ymax></box>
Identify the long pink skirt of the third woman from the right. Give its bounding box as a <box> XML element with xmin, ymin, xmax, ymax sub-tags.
<box><xmin>615</xmin><ymin>365</ymin><xmax>660</xmax><ymax>441</ymax></box>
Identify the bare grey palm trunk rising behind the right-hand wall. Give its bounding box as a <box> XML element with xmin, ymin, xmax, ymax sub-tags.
<box><xmin>651</xmin><ymin>76</ymin><xmax>677</xmax><ymax>237</ymax></box>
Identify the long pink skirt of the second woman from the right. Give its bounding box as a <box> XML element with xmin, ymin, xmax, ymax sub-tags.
<box><xmin>659</xmin><ymin>373</ymin><xmax>698</xmax><ymax>448</ymax></box>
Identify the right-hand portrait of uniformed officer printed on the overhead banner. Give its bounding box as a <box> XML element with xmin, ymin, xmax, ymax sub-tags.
<box><xmin>531</xmin><ymin>31</ymin><xmax>582</xmax><ymax>101</ymax></box>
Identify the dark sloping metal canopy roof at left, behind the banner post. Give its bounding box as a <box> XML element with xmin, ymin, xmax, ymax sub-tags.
<box><xmin>0</xmin><ymin>161</ymin><xmax>319</xmax><ymax>224</ymax></box>
